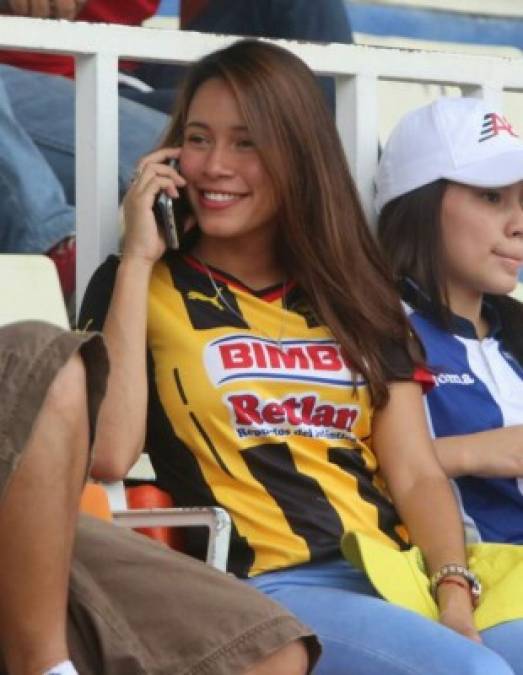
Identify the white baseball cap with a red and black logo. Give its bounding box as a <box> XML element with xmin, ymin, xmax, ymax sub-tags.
<box><xmin>375</xmin><ymin>97</ymin><xmax>523</xmax><ymax>213</ymax></box>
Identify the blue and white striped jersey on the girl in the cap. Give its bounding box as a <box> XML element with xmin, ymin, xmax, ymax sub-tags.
<box><xmin>405</xmin><ymin>285</ymin><xmax>523</xmax><ymax>544</ymax></box>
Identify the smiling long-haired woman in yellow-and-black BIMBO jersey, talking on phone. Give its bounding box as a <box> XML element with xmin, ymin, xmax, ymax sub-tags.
<box><xmin>81</xmin><ymin>40</ymin><xmax>523</xmax><ymax>675</ymax></box>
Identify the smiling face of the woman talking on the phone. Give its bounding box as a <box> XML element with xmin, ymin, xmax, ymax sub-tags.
<box><xmin>180</xmin><ymin>78</ymin><xmax>276</xmax><ymax>242</ymax></box>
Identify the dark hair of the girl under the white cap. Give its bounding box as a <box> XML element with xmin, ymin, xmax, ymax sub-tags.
<box><xmin>378</xmin><ymin>179</ymin><xmax>523</xmax><ymax>365</ymax></box>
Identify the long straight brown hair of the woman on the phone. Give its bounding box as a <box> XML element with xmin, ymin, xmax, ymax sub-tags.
<box><xmin>165</xmin><ymin>40</ymin><xmax>421</xmax><ymax>406</ymax></box>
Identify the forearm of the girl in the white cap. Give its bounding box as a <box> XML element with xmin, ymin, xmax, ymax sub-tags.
<box><xmin>434</xmin><ymin>424</ymin><xmax>523</xmax><ymax>478</ymax></box>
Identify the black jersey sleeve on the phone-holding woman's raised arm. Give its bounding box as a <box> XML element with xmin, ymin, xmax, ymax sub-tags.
<box><xmin>78</xmin><ymin>255</ymin><xmax>120</xmax><ymax>331</ymax></box>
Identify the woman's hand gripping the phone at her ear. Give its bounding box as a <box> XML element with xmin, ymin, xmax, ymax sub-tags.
<box><xmin>123</xmin><ymin>148</ymin><xmax>186</xmax><ymax>264</ymax></box>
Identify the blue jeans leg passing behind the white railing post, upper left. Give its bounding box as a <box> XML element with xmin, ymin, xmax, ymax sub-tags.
<box><xmin>0</xmin><ymin>64</ymin><xmax>168</xmax><ymax>211</ymax></box>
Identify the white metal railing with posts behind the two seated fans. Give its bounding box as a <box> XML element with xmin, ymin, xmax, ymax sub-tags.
<box><xmin>0</xmin><ymin>17</ymin><xmax>523</xmax><ymax>297</ymax></box>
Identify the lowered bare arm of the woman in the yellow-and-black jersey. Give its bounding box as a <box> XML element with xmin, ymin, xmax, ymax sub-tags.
<box><xmin>373</xmin><ymin>382</ymin><xmax>480</xmax><ymax>641</ymax></box>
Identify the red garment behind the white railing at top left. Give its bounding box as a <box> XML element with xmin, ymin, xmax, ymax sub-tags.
<box><xmin>0</xmin><ymin>0</ymin><xmax>160</xmax><ymax>77</ymax></box>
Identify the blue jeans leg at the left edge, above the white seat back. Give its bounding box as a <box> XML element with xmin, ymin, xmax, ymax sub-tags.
<box><xmin>0</xmin><ymin>76</ymin><xmax>75</xmax><ymax>253</ymax></box>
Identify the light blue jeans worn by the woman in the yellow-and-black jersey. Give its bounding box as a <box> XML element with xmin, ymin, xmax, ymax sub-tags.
<box><xmin>247</xmin><ymin>560</ymin><xmax>523</xmax><ymax>675</ymax></box>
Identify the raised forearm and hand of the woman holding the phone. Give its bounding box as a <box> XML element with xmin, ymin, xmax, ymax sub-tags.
<box><xmin>91</xmin><ymin>148</ymin><xmax>185</xmax><ymax>480</ymax></box>
